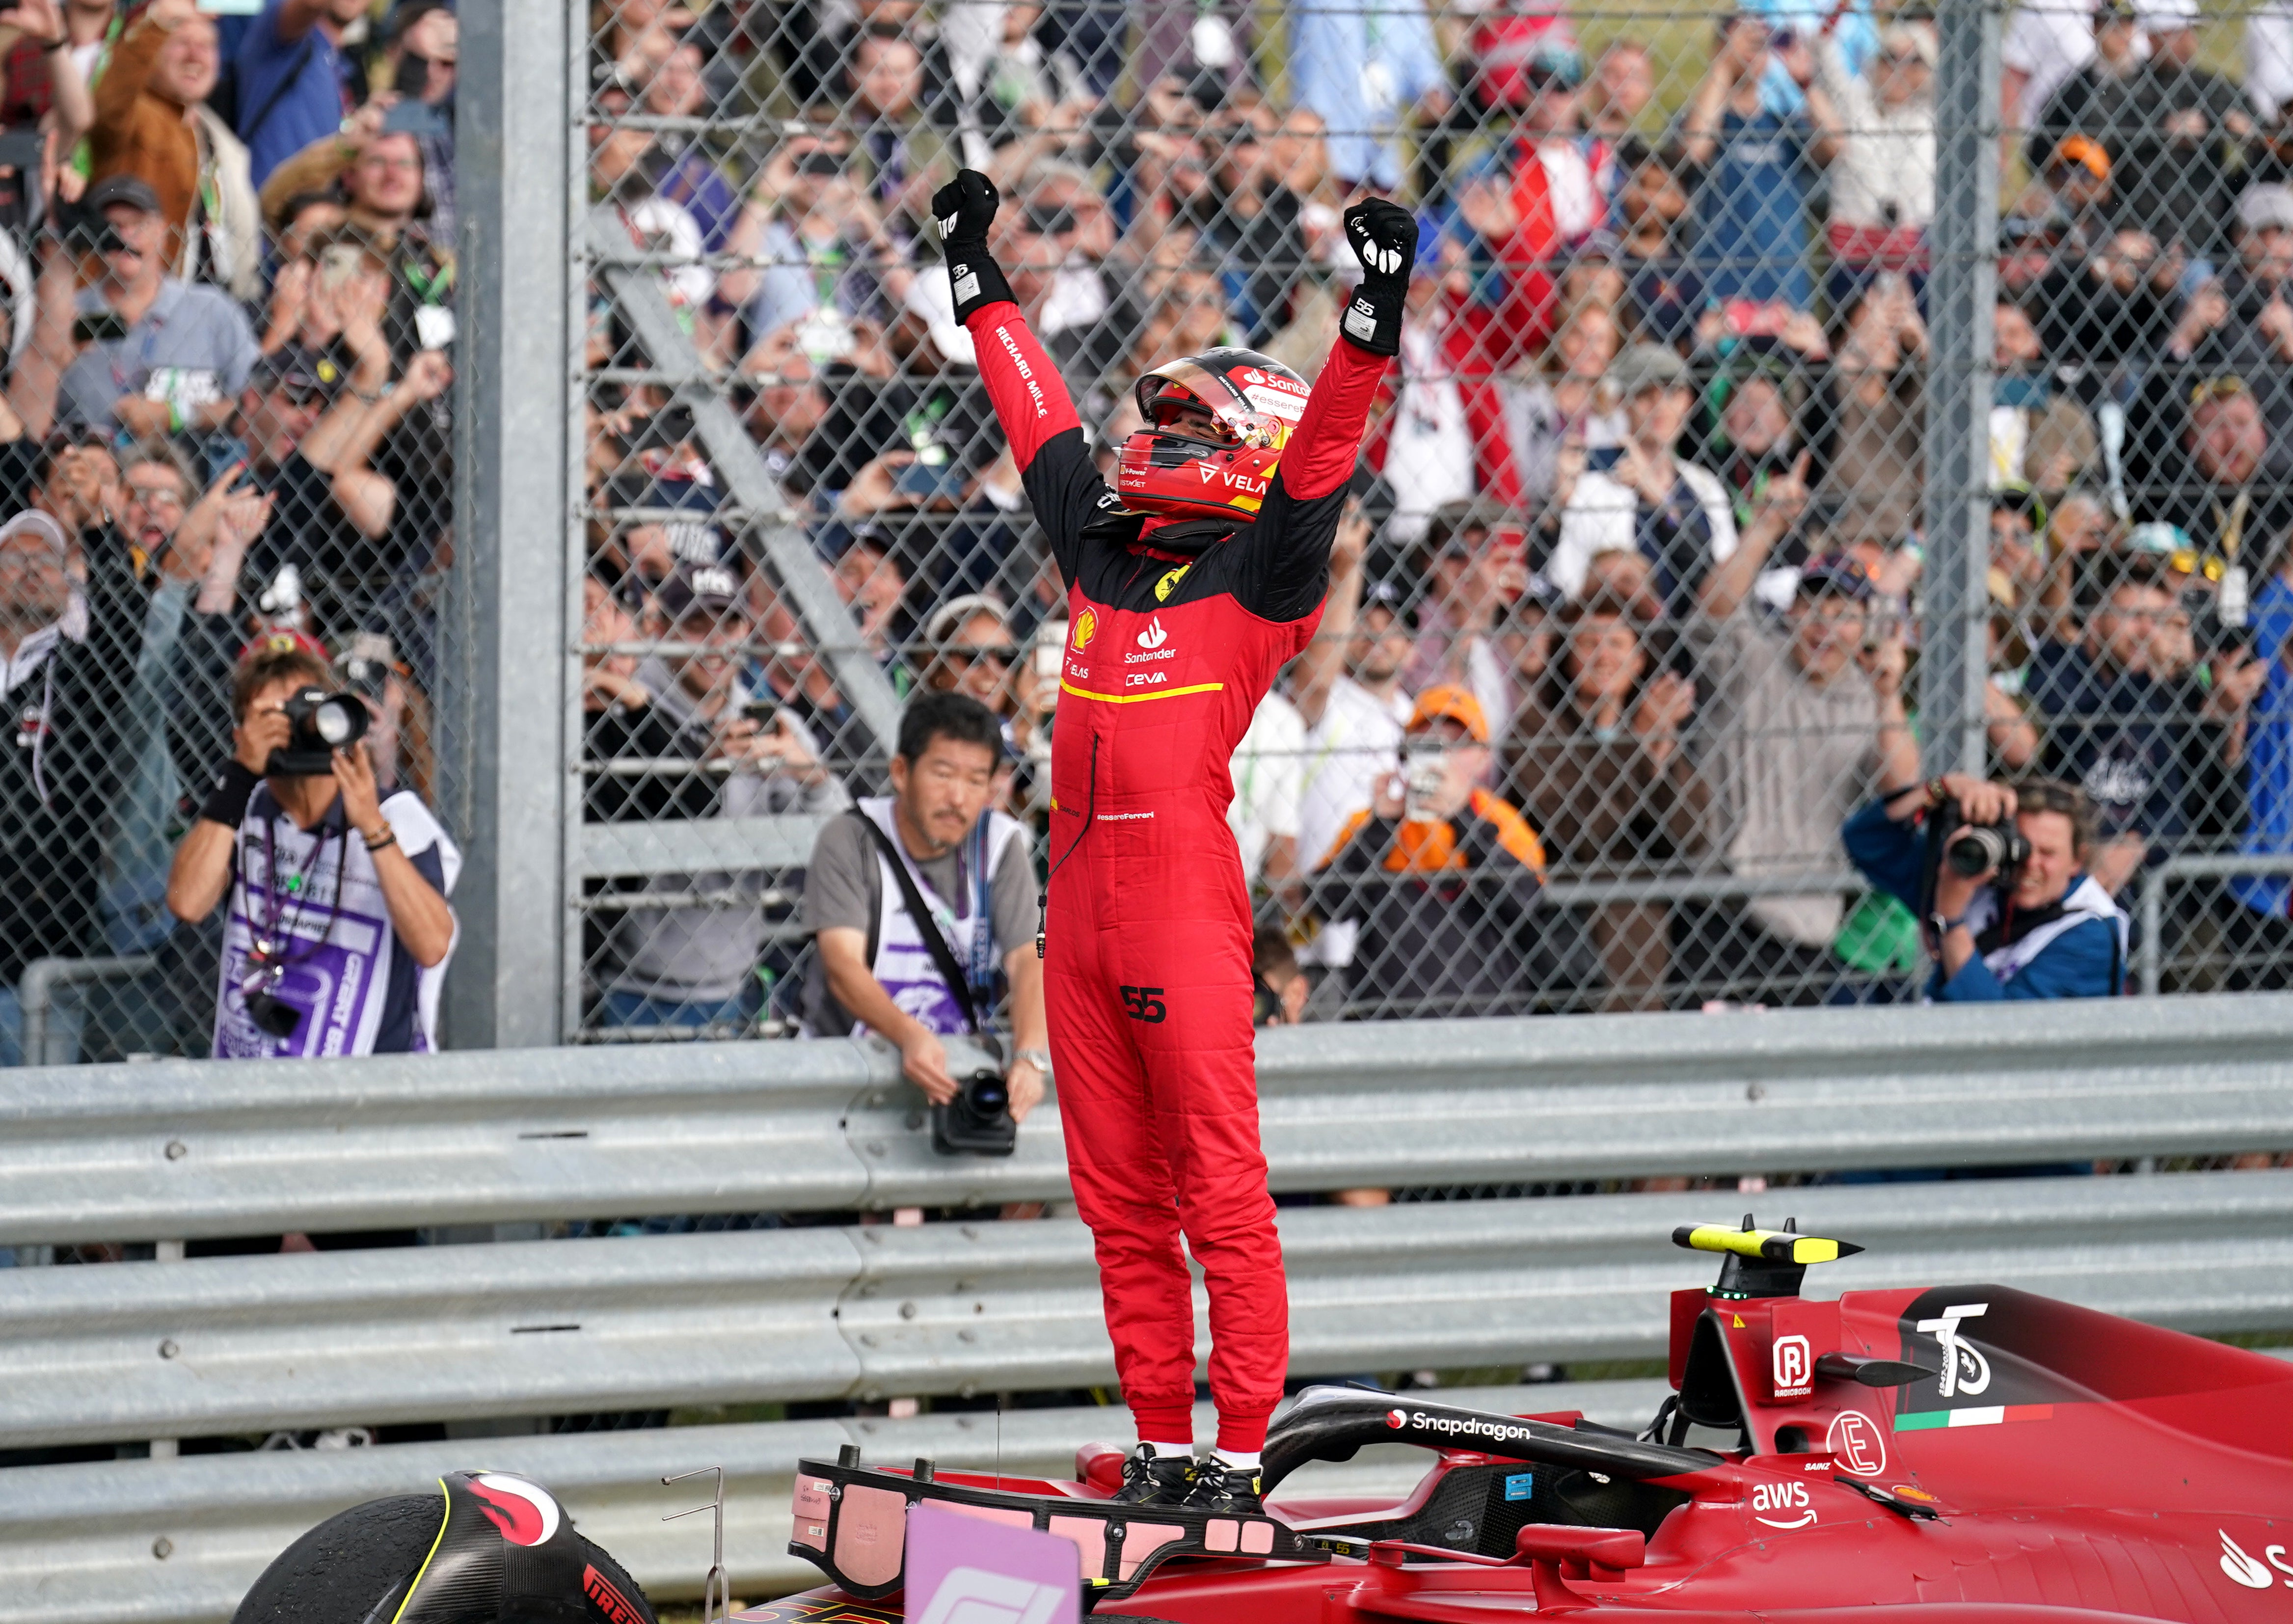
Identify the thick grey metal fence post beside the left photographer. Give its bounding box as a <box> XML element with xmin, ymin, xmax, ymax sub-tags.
<box><xmin>447</xmin><ymin>0</ymin><xmax>580</xmax><ymax>1048</ymax></box>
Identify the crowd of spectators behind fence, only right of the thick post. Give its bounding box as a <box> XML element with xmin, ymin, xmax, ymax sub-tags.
<box><xmin>559</xmin><ymin>0</ymin><xmax>2293</xmax><ymax>1023</ymax></box>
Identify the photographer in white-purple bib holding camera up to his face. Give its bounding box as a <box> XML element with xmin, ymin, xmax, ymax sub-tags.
<box><xmin>167</xmin><ymin>645</ymin><xmax>461</xmax><ymax>1060</ymax></box>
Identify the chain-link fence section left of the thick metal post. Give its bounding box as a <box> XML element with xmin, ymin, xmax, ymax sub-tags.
<box><xmin>0</xmin><ymin>0</ymin><xmax>461</xmax><ymax>1064</ymax></box>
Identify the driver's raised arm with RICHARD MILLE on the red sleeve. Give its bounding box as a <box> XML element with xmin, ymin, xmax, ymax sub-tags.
<box><xmin>931</xmin><ymin>170</ymin><xmax>1114</xmax><ymax>583</ymax></box>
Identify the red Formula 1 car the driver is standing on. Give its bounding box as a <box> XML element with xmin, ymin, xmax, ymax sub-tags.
<box><xmin>761</xmin><ymin>1218</ymin><xmax>2293</xmax><ymax>1624</ymax></box>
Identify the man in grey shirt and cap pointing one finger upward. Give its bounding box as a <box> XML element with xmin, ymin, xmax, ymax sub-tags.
<box><xmin>1681</xmin><ymin>480</ymin><xmax>1919</xmax><ymax>1002</ymax></box>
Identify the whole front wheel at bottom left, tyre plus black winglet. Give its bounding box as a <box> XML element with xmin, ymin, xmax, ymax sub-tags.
<box><xmin>232</xmin><ymin>1473</ymin><xmax>658</xmax><ymax>1624</ymax></box>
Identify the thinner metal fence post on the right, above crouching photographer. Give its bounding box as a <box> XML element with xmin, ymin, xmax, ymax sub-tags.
<box><xmin>1919</xmin><ymin>0</ymin><xmax>1999</xmax><ymax>773</ymax></box>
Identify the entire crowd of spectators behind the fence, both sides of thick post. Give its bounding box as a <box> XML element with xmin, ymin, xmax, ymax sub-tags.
<box><xmin>22</xmin><ymin>0</ymin><xmax>2293</xmax><ymax>1055</ymax></box>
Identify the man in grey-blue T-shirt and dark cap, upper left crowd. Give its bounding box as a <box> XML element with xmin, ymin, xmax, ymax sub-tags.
<box><xmin>57</xmin><ymin>174</ymin><xmax>259</xmax><ymax>440</ymax></box>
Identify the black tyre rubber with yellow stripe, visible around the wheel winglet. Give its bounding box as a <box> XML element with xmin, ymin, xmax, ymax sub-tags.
<box><xmin>232</xmin><ymin>1493</ymin><xmax>658</xmax><ymax>1624</ymax></box>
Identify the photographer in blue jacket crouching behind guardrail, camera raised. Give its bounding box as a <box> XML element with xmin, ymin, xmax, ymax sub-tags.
<box><xmin>1839</xmin><ymin>773</ymin><xmax>2128</xmax><ymax>1004</ymax></box>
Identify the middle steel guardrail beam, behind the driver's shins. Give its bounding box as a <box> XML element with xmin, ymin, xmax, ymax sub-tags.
<box><xmin>0</xmin><ymin>1170</ymin><xmax>2293</xmax><ymax>1447</ymax></box>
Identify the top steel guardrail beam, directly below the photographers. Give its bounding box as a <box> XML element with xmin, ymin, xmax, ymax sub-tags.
<box><xmin>13</xmin><ymin>993</ymin><xmax>2293</xmax><ymax>1245</ymax></box>
